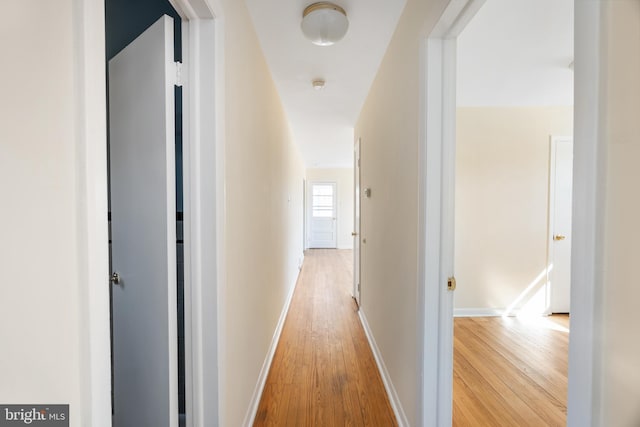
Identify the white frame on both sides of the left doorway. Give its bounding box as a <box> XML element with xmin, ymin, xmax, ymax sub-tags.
<box><xmin>73</xmin><ymin>0</ymin><xmax>224</xmax><ymax>426</ymax></box>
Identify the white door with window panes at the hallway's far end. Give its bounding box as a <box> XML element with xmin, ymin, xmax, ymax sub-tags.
<box><xmin>309</xmin><ymin>182</ymin><xmax>338</xmax><ymax>248</ymax></box>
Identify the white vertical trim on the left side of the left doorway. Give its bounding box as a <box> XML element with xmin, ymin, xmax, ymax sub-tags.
<box><xmin>73</xmin><ymin>0</ymin><xmax>111</xmax><ymax>427</ymax></box>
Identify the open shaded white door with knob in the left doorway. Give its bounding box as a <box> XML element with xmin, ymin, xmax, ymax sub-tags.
<box><xmin>109</xmin><ymin>16</ymin><xmax>178</xmax><ymax>427</ymax></box>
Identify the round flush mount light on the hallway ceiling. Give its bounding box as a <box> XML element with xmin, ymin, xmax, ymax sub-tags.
<box><xmin>301</xmin><ymin>1</ymin><xmax>349</xmax><ymax>46</ymax></box>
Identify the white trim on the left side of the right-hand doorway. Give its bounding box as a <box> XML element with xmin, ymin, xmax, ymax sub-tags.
<box><xmin>418</xmin><ymin>0</ymin><xmax>485</xmax><ymax>426</ymax></box>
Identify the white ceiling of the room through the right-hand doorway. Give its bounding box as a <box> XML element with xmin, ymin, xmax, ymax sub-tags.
<box><xmin>457</xmin><ymin>0</ymin><xmax>573</xmax><ymax>106</ymax></box>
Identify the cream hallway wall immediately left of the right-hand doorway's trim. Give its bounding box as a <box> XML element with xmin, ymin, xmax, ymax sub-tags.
<box><xmin>355</xmin><ymin>0</ymin><xmax>448</xmax><ymax>425</ymax></box>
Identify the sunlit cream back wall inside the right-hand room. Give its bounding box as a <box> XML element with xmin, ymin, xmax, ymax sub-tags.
<box><xmin>455</xmin><ymin>107</ymin><xmax>573</xmax><ymax>314</ymax></box>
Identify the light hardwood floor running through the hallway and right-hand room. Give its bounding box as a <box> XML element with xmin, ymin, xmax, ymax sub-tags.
<box><xmin>254</xmin><ymin>250</ymin><xmax>569</xmax><ymax>427</ymax></box>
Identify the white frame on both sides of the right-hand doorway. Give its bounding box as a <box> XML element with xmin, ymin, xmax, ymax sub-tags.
<box><xmin>419</xmin><ymin>0</ymin><xmax>606</xmax><ymax>426</ymax></box>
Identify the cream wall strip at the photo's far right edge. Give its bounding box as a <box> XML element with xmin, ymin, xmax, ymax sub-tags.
<box><xmin>597</xmin><ymin>0</ymin><xmax>640</xmax><ymax>426</ymax></box>
